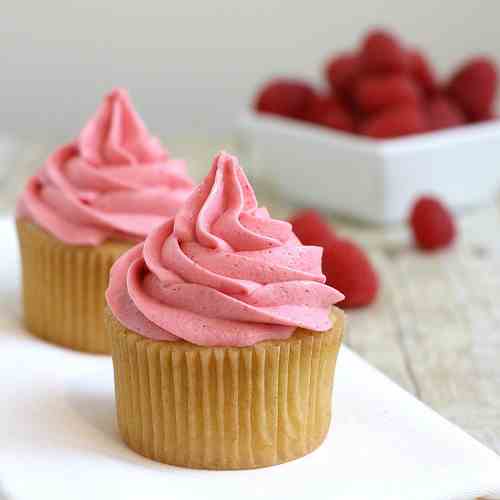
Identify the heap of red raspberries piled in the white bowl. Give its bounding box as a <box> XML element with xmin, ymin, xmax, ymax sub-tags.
<box><xmin>255</xmin><ymin>29</ymin><xmax>498</xmax><ymax>139</ymax></box>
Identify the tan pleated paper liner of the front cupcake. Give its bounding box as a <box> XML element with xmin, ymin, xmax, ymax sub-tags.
<box><xmin>105</xmin><ymin>308</ymin><xmax>344</xmax><ymax>469</ymax></box>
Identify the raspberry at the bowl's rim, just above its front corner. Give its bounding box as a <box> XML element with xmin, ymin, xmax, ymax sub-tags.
<box><xmin>359</xmin><ymin>106</ymin><xmax>427</xmax><ymax>139</ymax></box>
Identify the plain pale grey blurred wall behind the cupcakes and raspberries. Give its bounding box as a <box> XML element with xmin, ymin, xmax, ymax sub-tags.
<box><xmin>0</xmin><ymin>0</ymin><xmax>500</xmax><ymax>144</ymax></box>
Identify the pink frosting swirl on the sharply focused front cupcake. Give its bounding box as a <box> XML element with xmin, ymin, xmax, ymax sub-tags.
<box><xmin>106</xmin><ymin>153</ymin><xmax>343</xmax><ymax>346</ymax></box>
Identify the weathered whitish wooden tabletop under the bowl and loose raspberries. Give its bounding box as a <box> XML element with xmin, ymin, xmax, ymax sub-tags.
<box><xmin>0</xmin><ymin>136</ymin><xmax>500</xmax><ymax>453</ymax></box>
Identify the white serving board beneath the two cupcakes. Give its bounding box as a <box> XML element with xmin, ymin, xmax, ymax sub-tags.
<box><xmin>0</xmin><ymin>219</ymin><xmax>500</xmax><ymax>500</ymax></box>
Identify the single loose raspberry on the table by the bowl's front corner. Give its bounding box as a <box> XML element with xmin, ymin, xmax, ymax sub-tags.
<box><xmin>410</xmin><ymin>196</ymin><xmax>456</xmax><ymax>251</ymax></box>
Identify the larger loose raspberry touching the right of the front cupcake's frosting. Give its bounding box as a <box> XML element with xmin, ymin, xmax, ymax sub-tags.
<box><xmin>323</xmin><ymin>239</ymin><xmax>379</xmax><ymax>308</ymax></box>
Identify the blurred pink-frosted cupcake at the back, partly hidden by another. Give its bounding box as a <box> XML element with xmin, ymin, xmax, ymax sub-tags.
<box><xmin>16</xmin><ymin>89</ymin><xmax>193</xmax><ymax>353</ymax></box>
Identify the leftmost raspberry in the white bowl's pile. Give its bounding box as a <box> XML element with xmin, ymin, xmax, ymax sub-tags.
<box><xmin>255</xmin><ymin>79</ymin><xmax>314</xmax><ymax>119</ymax></box>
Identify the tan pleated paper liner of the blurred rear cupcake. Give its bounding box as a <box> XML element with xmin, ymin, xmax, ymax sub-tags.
<box><xmin>17</xmin><ymin>220</ymin><xmax>131</xmax><ymax>353</ymax></box>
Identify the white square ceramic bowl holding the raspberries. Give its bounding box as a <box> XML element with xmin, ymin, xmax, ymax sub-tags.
<box><xmin>237</xmin><ymin>112</ymin><xmax>500</xmax><ymax>223</ymax></box>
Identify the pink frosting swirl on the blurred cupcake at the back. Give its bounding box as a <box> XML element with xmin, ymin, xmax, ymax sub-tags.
<box><xmin>17</xmin><ymin>89</ymin><xmax>194</xmax><ymax>245</ymax></box>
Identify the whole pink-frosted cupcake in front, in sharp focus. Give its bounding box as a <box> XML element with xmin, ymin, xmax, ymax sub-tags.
<box><xmin>105</xmin><ymin>153</ymin><xmax>344</xmax><ymax>469</ymax></box>
